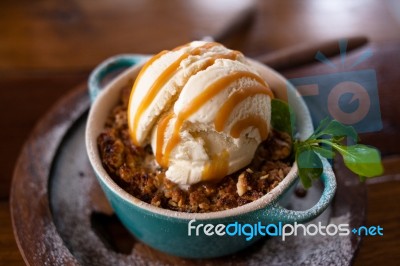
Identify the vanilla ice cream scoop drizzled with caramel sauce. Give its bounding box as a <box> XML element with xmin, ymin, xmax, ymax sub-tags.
<box><xmin>128</xmin><ymin>41</ymin><xmax>273</xmax><ymax>187</ymax></box>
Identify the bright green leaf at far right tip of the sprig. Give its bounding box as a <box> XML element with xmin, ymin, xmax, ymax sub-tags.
<box><xmin>335</xmin><ymin>144</ymin><xmax>383</xmax><ymax>177</ymax></box>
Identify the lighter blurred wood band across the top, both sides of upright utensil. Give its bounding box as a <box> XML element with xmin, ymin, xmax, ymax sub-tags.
<box><xmin>0</xmin><ymin>0</ymin><xmax>400</xmax><ymax>70</ymax></box>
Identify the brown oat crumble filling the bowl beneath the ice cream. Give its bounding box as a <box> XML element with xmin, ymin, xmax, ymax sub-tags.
<box><xmin>97</xmin><ymin>87</ymin><xmax>292</xmax><ymax>212</ymax></box>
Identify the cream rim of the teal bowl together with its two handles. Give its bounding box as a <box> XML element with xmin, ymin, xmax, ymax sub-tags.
<box><xmin>86</xmin><ymin>54</ymin><xmax>336</xmax><ymax>223</ymax></box>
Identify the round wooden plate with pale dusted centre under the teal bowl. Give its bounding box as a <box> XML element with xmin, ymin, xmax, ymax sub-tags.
<box><xmin>10</xmin><ymin>82</ymin><xmax>366</xmax><ymax>265</ymax></box>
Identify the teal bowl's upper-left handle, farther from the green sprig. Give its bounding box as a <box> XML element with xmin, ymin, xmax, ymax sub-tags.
<box><xmin>88</xmin><ymin>54</ymin><xmax>150</xmax><ymax>102</ymax></box>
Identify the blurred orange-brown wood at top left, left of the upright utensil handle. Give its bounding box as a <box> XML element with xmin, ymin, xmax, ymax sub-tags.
<box><xmin>0</xmin><ymin>0</ymin><xmax>255</xmax><ymax>70</ymax></box>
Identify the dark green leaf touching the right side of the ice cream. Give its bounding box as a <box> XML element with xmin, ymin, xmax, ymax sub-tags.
<box><xmin>271</xmin><ymin>99</ymin><xmax>295</xmax><ymax>137</ymax></box>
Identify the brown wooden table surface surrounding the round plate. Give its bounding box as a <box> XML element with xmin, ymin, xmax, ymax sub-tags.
<box><xmin>0</xmin><ymin>0</ymin><xmax>400</xmax><ymax>265</ymax></box>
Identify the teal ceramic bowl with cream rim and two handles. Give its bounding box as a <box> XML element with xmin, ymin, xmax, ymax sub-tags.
<box><xmin>86</xmin><ymin>55</ymin><xmax>336</xmax><ymax>258</ymax></box>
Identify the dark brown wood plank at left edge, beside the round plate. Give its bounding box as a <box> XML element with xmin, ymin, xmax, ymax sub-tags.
<box><xmin>0</xmin><ymin>72</ymin><xmax>88</xmax><ymax>199</ymax></box>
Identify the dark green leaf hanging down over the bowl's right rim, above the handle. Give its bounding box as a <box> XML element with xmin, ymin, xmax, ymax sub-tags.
<box><xmin>296</xmin><ymin>147</ymin><xmax>323</xmax><ymax>188</ymax></box>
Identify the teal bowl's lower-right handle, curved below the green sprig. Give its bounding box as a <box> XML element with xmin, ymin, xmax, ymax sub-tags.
<box><xmin>264</xmin><ymin>159</ymin><xmax>336</xmax><ymax>223</ymax></box>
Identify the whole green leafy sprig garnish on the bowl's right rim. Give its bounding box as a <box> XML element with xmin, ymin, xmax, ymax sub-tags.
<box><xmin>271</xmin><ymin>99</ymin><xmax>383</xmax><ymax>188</ymax></box>
